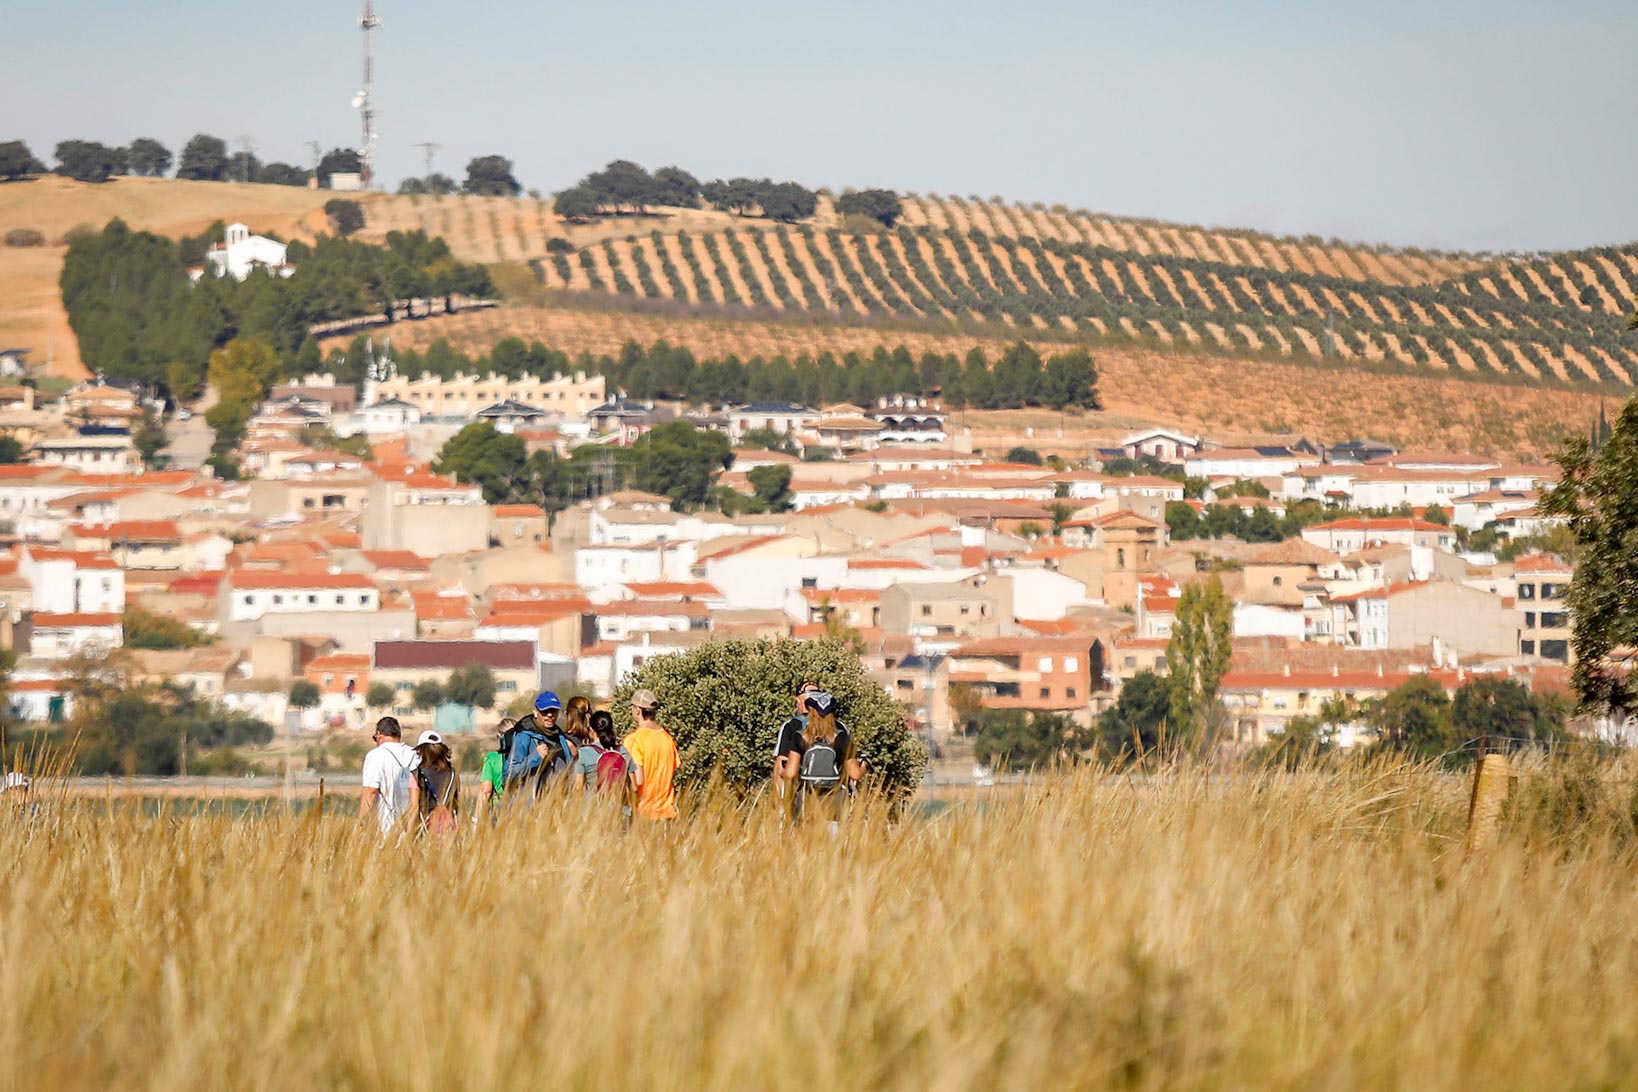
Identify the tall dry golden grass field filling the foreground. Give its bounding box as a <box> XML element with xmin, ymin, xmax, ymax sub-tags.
<box><xmin>12</xmin><ymin>766</ymin><xmax>1638</xmax><ymax>1089</ymax></box>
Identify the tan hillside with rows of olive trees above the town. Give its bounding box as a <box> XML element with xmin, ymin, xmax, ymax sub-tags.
<box><xmin>0</xmin><ymin>178</ymin><xmax>1638</xmax><ymax>450</ymax></box>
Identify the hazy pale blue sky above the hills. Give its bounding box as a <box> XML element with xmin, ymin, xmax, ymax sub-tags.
<box><xmin>0</xmin><ymin>0</ymin><xmax>1638</xmax><ymax>249</ymax></box>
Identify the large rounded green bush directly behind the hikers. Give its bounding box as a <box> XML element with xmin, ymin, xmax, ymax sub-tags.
<box><xmin>613</xmin><ymin>640</ymin><xmax>927</xmax><ymax>796</ymax></box>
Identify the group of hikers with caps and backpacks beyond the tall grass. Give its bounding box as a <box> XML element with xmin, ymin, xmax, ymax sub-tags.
<box><xmin>359</xmin><ymin>683</ymin><xmax>867</xmax><ymax>837</ymax></box>
